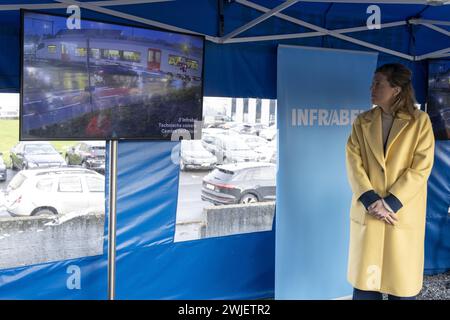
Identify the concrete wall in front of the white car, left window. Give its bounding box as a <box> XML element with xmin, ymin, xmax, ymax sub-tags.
<box><xmin>0</xmin><ymin>212</ymin><xmax>105</xmax><ymax>269</ymax></box>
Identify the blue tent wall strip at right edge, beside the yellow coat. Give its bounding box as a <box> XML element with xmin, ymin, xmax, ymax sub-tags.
<box><xmin>425</xmin><ymin>141</ymin><xmax>450</xmax><ymax>274</ymax></box>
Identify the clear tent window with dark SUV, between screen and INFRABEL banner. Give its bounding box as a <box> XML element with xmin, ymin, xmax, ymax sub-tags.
<box><xmin>174</xmin><ymin>97</ymin><xmax>277</xmax><ymax>242</ymax></box>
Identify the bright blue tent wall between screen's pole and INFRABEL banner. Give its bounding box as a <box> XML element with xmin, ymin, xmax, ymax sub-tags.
<box><xmin>112</xmin><ymin>141</ymin><xmax>275</xmax><ymax>299</ymax></box>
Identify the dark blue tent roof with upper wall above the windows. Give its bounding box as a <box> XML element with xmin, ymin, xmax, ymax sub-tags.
<box><xmin>0</xmin><ymin>0</ymin><xmax>450</xmax><ymax>98</ymax></box>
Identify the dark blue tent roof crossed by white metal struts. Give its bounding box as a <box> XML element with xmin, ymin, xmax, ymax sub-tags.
<box><xmin>0</xmin><ymin>0</ymin><xmax>450</xmax><ymax>61</ymax></box>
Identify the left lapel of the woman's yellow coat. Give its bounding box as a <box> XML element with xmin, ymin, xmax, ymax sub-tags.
<box><xmin>361</xmin><ymin>107</ymin><xmax>385</xmax><ymax>168</ymax></box>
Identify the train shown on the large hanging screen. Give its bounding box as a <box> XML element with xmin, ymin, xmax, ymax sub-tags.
<box><xmin>33</xmin><ymin>29</ymin><xmax>202</xmax><ymax>81</ymax></box>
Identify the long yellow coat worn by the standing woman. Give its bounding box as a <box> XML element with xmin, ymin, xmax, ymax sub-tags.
<box><xmin>346</xmin><ymin>107</ymin><xmax>434</xmax><ymax>297</ymax></box>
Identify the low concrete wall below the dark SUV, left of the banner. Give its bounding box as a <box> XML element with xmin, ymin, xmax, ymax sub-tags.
<box><xmin>201</xmin><ymin>202</ymin><xmax>275</xmax><ymax>238</ymax></box>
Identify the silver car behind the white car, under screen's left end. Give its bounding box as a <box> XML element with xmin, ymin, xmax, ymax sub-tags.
<box><xmin>10</xmin><ymin>142</ymin><xmax>66</xmax><ymax>170</ymax></box>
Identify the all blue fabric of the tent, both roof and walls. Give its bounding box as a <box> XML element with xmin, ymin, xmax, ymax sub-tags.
<box><xmin>0</xmin><ymin>0</ymin><xmax>450</xmax><ymax>299</ymax></box>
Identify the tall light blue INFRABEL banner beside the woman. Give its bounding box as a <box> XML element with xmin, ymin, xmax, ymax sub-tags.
<box><xmin>275</xmin><ymin>46</ymin><xmax>377</xmax><ymax>299</ymax></box>
